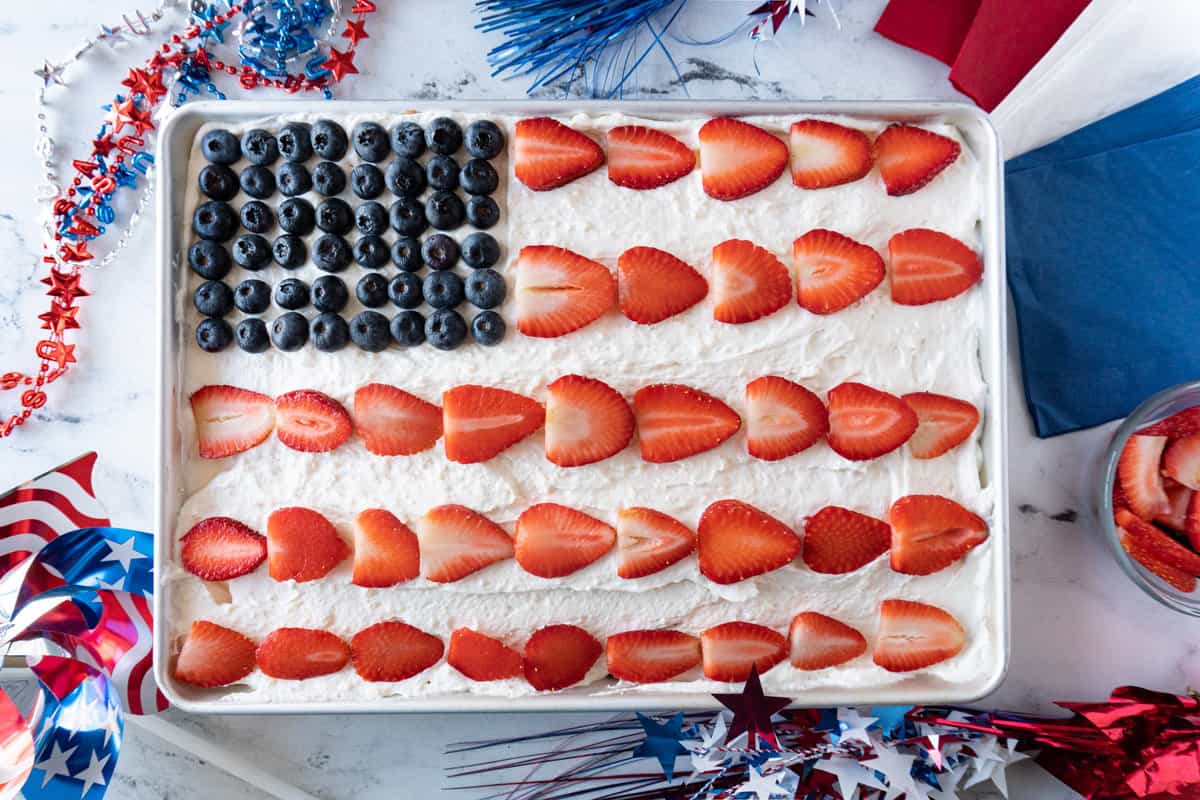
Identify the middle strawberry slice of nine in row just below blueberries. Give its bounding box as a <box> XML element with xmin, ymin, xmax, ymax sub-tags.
<box><xmin>546</xmin><ymin>375</ymin><xmax>634</xmax><ymax>467</ymax></box>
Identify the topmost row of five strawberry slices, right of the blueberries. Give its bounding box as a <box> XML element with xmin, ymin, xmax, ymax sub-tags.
<box><xmin>514</xmin><ymin>116</ymin><xmax>961</xmax><ymax>200</ymax></box>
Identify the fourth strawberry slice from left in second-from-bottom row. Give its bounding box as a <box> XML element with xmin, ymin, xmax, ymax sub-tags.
<box><xmin>416</xmin><ymin>505</ymin><xmax>512</xmax><ymax>583</ymax></box>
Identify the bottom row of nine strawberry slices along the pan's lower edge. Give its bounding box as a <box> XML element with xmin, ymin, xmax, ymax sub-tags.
<box><xmin>174</xmin><ymin>600</ymin><xmax>966</xmax><ymax>691</ymax></box>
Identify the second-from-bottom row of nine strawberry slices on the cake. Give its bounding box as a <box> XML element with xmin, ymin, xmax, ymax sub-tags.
<box><xmin>180</xmin><ymin>494</ymin><xmax>988</xmax><ymax>588</ymax></box>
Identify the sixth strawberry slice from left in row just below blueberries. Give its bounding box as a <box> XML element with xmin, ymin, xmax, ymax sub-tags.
<box><xmin>634</xmin><ymin>384</ymin><xmax>742</xmax><ymax>463</ymax></box>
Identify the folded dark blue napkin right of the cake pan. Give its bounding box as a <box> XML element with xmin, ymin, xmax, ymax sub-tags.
<box><xmin>1006</xmin><ymin>78</ymin><xmax>1200</xmax><ymax>437</ymax></box>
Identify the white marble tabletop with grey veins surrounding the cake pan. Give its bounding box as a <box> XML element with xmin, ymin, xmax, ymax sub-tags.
<box><xmin>0</xmin><ymin>0</ymin><xmax>1200</xmax><ymax>800</ymax></box>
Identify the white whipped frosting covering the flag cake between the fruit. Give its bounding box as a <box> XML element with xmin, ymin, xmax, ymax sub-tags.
<box><xmin>163</xmin><ymin>113</ymin><xmax>1002</xmax><ymax>704</ymax></box>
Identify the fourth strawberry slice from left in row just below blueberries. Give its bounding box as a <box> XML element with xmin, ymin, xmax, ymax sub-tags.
<box><xmin>442</xmin><ymin>384</ymin><xmax>546</xmax><ymax>464</ymax></box>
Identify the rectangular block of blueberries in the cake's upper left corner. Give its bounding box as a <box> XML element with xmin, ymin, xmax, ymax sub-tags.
<box><xmin>188</xmin><ymin>118</ymin><xmax>506</xmax><ymax>353</ymax></box>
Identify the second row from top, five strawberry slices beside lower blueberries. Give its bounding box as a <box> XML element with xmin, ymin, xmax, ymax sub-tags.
<box><xmin>515</xmin><ymin>228</ymin><xmax>983</xmax><ymax>338</ymax></box>
